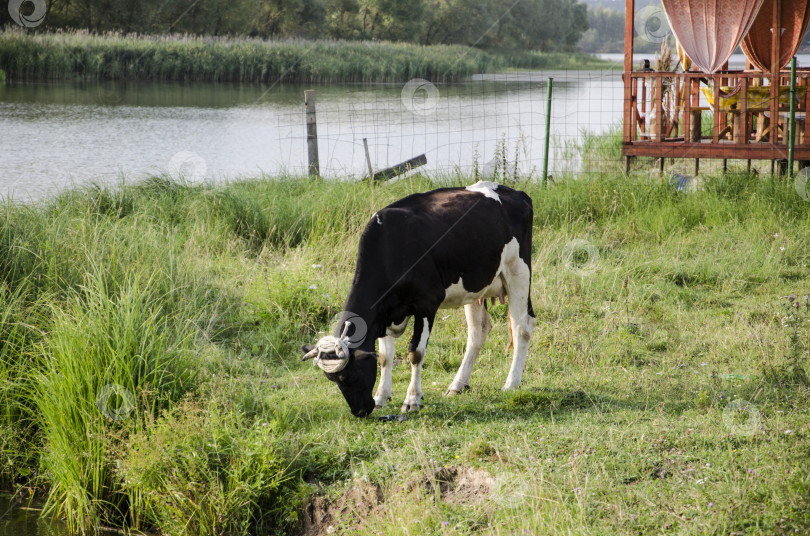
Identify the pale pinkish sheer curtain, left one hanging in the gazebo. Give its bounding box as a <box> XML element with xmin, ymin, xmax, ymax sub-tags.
<box><xmin>662</xmin><ymin>0</ymin><xmax>763</xmax><ymax>74</ymax></box>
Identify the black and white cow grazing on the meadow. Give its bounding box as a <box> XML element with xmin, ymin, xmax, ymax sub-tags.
<box><xmin>302</xmin><ymin>182</ymin><xmax>537</xmax><ymax>417</ymax></box>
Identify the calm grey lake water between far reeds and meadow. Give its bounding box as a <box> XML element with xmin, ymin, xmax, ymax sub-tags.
<box><xmin>0</xmin><ymin>71</ymin><xmax>622</xmax><ymax>200</ymax></box>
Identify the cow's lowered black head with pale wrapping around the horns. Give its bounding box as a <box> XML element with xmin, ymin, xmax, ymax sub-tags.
<box><xmin>301</xmin><ymin>328</ymin><xmax>377</xmax><ymax>417</ymax></box>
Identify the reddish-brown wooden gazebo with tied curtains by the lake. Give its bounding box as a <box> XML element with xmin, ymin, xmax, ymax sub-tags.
<box><xmin>622</xmin><ymin>0</ymin><xmax>810</xmax><ymax>171</ymax></box>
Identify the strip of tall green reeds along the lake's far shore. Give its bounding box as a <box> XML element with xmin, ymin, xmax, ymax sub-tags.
<box><xmin>0</xmin><ymin>29</ymin><xmax>616</xmax><ymax>83</ymax></box>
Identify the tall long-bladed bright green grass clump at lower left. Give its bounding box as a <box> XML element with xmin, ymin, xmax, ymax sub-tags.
<box><xmin>32</xmin><ymin>268</ymin><xmax>205</xmax><ymax>531</ymax></box>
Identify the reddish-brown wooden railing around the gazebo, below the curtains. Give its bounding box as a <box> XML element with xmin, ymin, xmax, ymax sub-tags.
<box><xmin>623</xmin><ymin>70</ymin><xmax>810</xmax><ymax>160</ymax></box>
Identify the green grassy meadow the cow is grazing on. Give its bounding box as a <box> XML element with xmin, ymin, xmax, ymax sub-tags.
<box><xmin>0</xmin><ymin>165</ymin><xmax>810</xmax><ymax>535</ymax></box>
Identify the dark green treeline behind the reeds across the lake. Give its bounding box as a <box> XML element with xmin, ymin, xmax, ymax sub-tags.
<box><xmin>0</xmin><ymin>0</ymin><xmax>588</xmax><ymax>51</ymax></box>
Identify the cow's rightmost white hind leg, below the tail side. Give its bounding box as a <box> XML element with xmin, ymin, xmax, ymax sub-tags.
<box><xmin>503</xmin><ymin>258</ymin><xmax>537</xmax><ymax>390</ymax></box>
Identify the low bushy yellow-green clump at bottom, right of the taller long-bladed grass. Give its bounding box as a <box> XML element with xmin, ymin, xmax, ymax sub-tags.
<box><xmin>120</xmin><ymin>400</ymin><xmax>299</xmax><ymax>536</ymax></box>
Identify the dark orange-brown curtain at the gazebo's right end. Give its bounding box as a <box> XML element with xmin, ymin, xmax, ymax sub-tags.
<box><xmin>742</xmin><ymin>0</ymin><xmax>810</xmax><ymax>72</ymax></box>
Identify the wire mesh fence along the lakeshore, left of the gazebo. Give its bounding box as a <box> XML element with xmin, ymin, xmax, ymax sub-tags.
<box><xmin>269</xmin><ymin>71</ymin><xmax>622</xmax><ymax>179</ymax></box>
